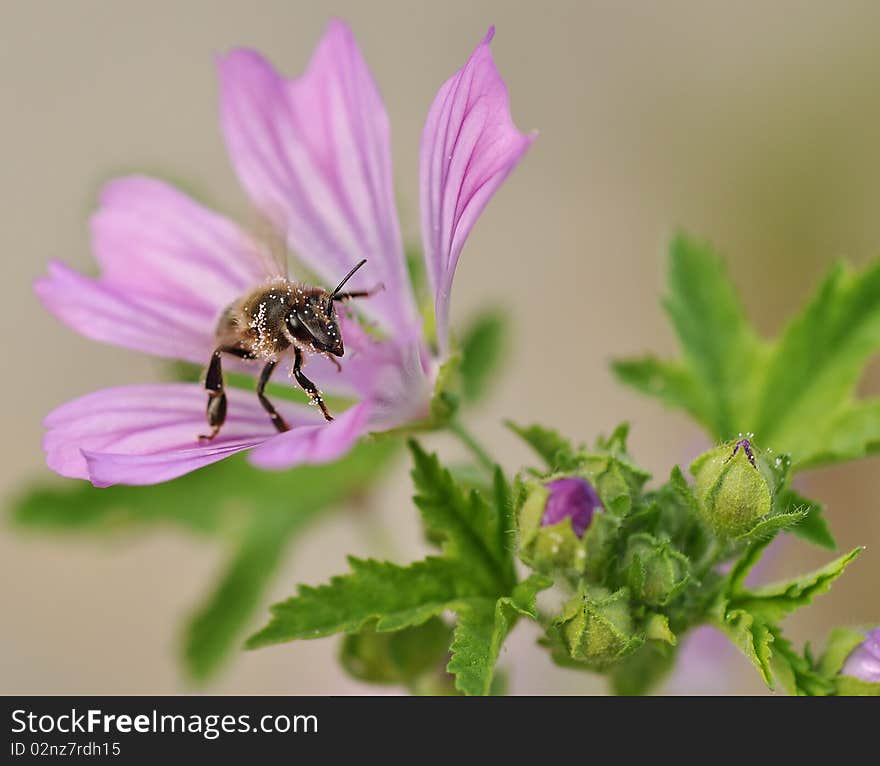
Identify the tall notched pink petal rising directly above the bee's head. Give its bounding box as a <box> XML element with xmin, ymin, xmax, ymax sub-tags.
<box><xmin>218</xmin><ymin>21</ymin><xmax>419</xmax><ymax>334</ymax></box>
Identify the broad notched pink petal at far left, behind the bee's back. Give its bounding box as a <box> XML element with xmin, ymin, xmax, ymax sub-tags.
<box><xmin>35</xmin><ymin>177</ymin><xmax>270</xmax><ymax>363</ymax></box>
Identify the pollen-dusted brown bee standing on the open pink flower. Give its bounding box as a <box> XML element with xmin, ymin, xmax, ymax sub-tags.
<box><xmin>199</xmin><ymin>259</ymin><xmax>384</xmax><ymax>441</ymax></box>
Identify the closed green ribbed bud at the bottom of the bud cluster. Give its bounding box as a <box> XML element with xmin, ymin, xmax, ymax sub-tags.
<box><xmin>556</xmin><ymin>585</ymin><xmax>644</xmax><ymax>668</ymax></box>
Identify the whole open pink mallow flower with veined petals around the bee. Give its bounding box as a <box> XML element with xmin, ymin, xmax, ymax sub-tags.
<box><xmin>35</xmin><ymin>21</ymin><xmax>532</xmax><ymax>486</ymax></box>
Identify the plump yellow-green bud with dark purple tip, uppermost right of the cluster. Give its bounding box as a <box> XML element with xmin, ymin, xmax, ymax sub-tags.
<box><xmin>691</xmin><ymin>439</ymin><xmax>775</xmax><ymax>538</ymax></box>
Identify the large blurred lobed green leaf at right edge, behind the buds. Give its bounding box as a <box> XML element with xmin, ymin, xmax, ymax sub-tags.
<box><xmin>613</xmin><ymin>236</ymin><xmax>880</xmax><ymax>474</ymax></box>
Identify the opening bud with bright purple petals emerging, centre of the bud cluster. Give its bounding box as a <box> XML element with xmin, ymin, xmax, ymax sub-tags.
<box><xmin>519</xmin><ymin>476</ymin><xmax>602</xmax><ymax>572</ymax></box>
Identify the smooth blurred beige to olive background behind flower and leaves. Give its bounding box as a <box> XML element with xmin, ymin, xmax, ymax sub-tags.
<box><xmin>0</xmin><ymin>0</ymin><xmax>880</xmax><ymax>693</ymax></box>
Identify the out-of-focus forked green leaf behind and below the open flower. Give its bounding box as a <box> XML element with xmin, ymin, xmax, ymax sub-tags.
<box><xmin>11</xmin><ymin>441</ymin><xmax>398</xmax><ymax>682</ymax></box>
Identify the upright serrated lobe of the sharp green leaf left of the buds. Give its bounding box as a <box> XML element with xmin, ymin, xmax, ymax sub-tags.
<box><xmin>410</xmin><ymin>442</ymin><xmax>516</xmax><ymax>594</ymax></box>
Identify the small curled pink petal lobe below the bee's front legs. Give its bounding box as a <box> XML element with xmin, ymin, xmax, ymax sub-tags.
<box><xmin>250</xmin><ymin>402</ymin><xmax>371</xmax><ymax>470</ymax></box>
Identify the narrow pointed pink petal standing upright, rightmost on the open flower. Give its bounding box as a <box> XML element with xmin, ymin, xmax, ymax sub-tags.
<box><xmin>419</xmin><ymin>27</ymin><xmax>534</xmax><ymax>351</ymax></box>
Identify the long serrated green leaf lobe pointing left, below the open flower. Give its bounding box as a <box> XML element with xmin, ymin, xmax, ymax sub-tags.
<box><xmin>247</xmin><ymin>557</ymin><xmax>479</xmax><ymax>649</ymax></box>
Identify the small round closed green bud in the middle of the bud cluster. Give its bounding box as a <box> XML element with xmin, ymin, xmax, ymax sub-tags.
<box><xmin>624</xmin><ymin>532</ymin><xmax>690</xmax><ymax>606</ymax></box>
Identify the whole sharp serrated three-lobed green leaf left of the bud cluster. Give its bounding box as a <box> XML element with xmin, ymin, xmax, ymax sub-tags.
<box><xmin>248</xmin><ymin>442</ymin><xmax>551</xmax><ymax>694</ymax></box>
